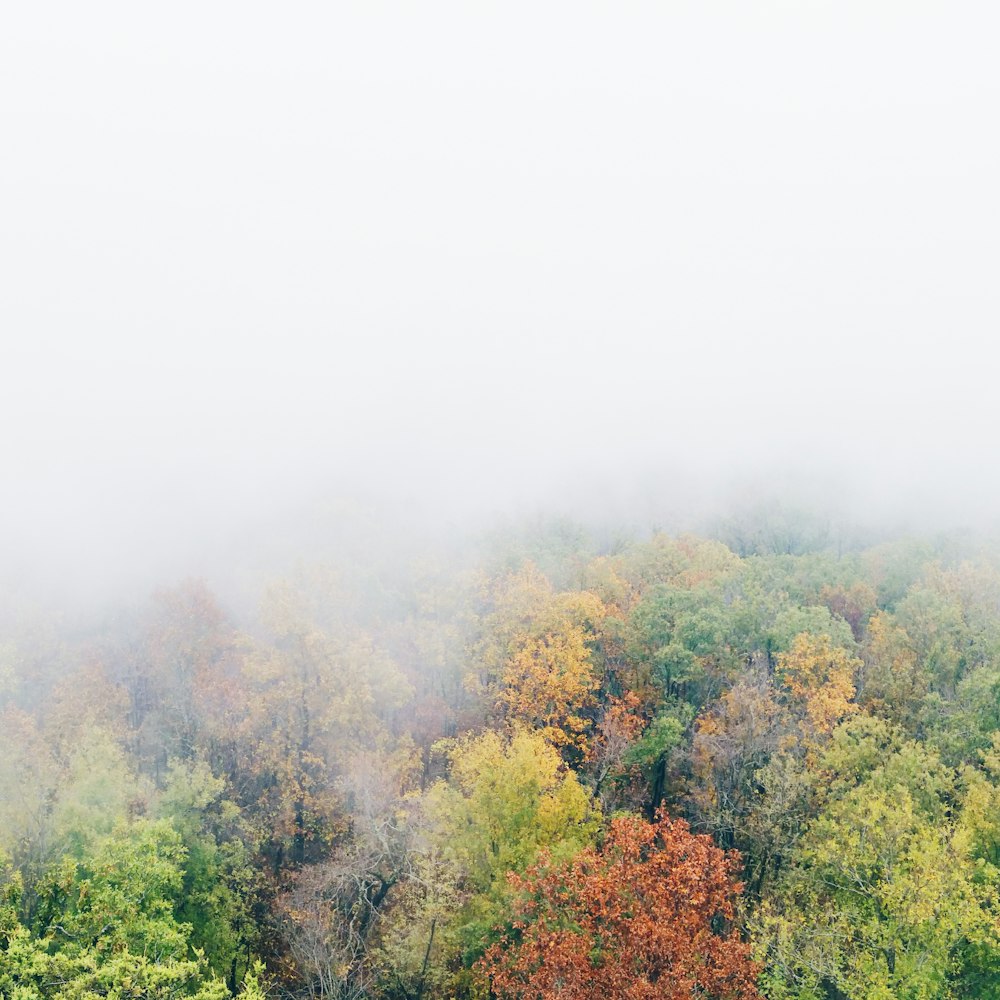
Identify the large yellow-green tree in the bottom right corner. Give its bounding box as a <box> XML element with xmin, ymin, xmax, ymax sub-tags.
<box><xmin>753</xmin><ymin>715</ymin><xmax>1000</xmax><ymax>1000</ymax></box>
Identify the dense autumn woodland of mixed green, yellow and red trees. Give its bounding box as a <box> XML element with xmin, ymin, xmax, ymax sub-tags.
<box><xmin>0</xmin><ymin>518</ymin><xmax>1000</xmax><ymax>1000</ymax></box>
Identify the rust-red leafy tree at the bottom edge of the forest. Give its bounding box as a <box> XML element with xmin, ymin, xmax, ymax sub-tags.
<box><xmin>479</xmin><ymin>813</ymin><xmax>760</xmax><ymax>1000</ymax></box>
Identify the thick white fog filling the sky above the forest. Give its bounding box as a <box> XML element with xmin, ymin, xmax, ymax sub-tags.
<box><xmin>0</xmin><ymin>2</ymin><xmax>1000</xmax><ymax>594</ymax></box>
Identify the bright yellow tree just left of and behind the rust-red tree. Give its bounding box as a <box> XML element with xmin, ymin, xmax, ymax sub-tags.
<box><xmin>383</xmin><ymin>728</ymin><xmax>600</xmax><ymax>996</ymax></box>
